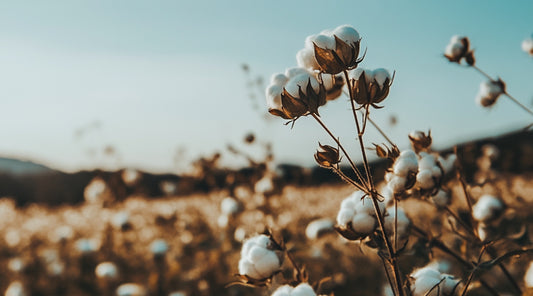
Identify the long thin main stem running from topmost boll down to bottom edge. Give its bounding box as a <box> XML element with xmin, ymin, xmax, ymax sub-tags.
<box><xmin>344</xmin><ymin>70</ymin><xmax>405</xmax><ymax>296</ymax></box>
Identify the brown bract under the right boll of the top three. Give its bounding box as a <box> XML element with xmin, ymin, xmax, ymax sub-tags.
<box><xmin>350</xmin><ymin>71</ymin><xmax>391</xmax><ymax>108</ymax></box>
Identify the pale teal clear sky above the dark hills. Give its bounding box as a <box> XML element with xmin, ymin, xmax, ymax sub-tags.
<box><xmin>0</xmin><ymin>0</ymin><xmax>533</xmax><ymax>173</ymax></box>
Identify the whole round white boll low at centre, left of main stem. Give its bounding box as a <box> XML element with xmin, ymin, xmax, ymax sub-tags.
<box><xmin>239</xmin><ymin>234</ymin><xmax>281</xmax><ymax>279</ymax></box>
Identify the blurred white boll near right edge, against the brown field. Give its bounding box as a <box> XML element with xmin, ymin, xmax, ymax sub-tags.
<box><xmin>472</xmin><ymin>194</ymin><xmax>505</xmax><ymax>241</ymax></box>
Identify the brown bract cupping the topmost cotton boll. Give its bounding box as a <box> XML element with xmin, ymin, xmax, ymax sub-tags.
<box><xmin>313</xmin><ymin>35</ymin><xmax>362</xmax><ymax>74</ymax></box>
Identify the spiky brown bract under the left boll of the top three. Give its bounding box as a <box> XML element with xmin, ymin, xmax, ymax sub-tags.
<box><xmin>268</xmin><ymin>78</ymin><xmax>326</xmax><ymax>119</ymax></box>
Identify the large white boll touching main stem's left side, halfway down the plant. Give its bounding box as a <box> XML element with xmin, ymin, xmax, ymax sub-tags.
<box><xmin>337</xmin><ymin>191</ymin><xmax>385</xmax><ymax>238</ymax></box>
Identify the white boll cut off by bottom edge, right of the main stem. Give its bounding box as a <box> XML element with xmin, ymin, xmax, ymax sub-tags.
<box><xmin>411</xmin><ymin>266</ymin><xmax>461</xmax><ymax>296</ymax></box>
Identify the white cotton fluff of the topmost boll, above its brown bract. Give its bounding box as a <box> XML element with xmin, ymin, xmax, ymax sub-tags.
<box><xmin>296</xmin><ymin>25</ymin><xmax>361</xmax><ymax>70</ymax></box>
